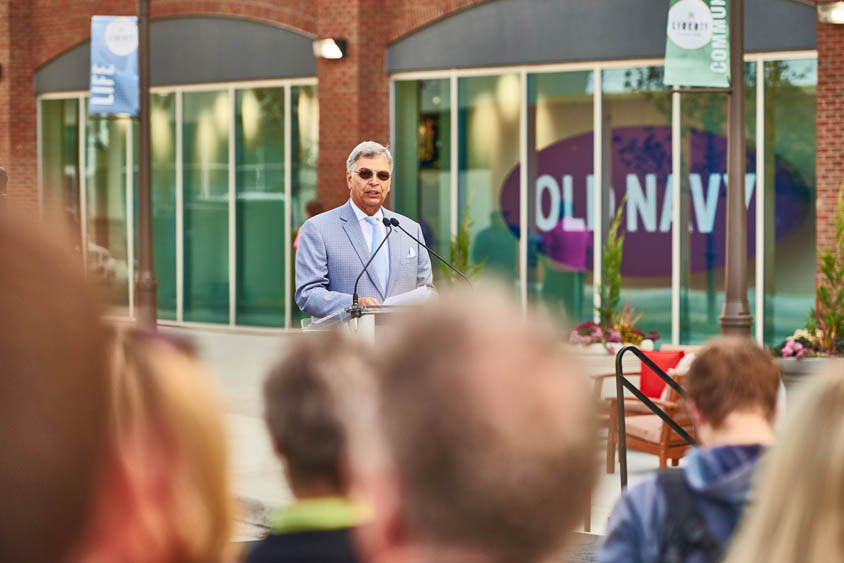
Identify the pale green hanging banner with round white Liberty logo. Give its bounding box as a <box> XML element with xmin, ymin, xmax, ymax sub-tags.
<box><xmin>665</xmin><ymin>0</ymin><xmax>730</xmax><ymax>88</ymax></box>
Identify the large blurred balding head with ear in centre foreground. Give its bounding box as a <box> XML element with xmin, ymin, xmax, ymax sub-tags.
<box><xmin>350</xmin><ymin>288</ymin><xmax>597</xmax><ymax>563</ymax></box>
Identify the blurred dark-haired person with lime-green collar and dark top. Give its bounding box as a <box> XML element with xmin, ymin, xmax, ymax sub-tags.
<box><xmin>248</xmin><ymin>332</ymin><xmax>369</xmax><ymax>563</ymax></box>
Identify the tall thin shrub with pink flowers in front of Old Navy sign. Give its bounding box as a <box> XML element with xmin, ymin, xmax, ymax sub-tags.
<box><xmin>569</xmin><ymin>196</ymin><xmax>659</xmax><ymax>371</ymax></box>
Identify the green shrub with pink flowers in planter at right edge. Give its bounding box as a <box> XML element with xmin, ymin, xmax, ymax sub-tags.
<box><xmin>773</xmin><ymin>184</ymin><xmax>844</xmax><ymax>387</ymax></box>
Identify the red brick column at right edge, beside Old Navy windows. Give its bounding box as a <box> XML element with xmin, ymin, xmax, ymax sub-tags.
<box><xmin>816</xmin><ymin>19</ymin><xmax>844</xmax><ymax>262</ymax></box>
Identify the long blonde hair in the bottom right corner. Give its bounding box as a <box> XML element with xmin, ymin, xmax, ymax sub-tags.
<box><xmin>726</xmin><ymin>363</ymin><xmax>844</xmax><ymax>563</ymax></box>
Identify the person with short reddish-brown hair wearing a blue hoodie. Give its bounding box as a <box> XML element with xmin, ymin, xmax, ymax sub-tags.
<box><xmin>598</xmin><ymin>338</ymin><xmax>780</xmax><ymax>563</ymax></box>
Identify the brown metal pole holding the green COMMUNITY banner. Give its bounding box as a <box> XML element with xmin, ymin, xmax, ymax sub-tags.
<box><xmin>720</xmin><ymin>0</ymin><xmax>753</xmax><ymax>338</ymax></box>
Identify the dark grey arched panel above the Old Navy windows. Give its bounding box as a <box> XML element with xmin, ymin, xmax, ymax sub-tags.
<box><xmin>387</xmin><ymin>0</ymin><xmax>817</xmax><ymax>73</ymax></box>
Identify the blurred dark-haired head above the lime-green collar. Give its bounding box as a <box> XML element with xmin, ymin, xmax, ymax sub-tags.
<box><xmin>264</xmin><ymin>332</ymin><xmax>370</xmax><ymax>499</ymax></box>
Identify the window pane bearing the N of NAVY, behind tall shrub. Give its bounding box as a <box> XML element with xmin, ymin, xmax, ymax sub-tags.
<box><xmin>602</xmin><ymin>67</ymin><xmax>672</xmax><ymax>342</ymax></box>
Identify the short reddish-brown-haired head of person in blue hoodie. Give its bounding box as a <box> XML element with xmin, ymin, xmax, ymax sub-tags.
<box><xmin>685</xmin><ymin>337</ymin><xmax>780</xmax><ymax>446</ymax></box>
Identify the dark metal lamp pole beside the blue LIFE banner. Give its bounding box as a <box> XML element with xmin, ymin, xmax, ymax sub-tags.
<box><xmin>135</xmin><ymin>0</ymin><xmax>158</xmax><ymax>330</ymax></box>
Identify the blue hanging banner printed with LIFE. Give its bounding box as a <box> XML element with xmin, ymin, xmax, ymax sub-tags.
<box><xmin>88</xmin><ymin>16</ymin><xmax>139</xmax><ymax>117</ymax></box>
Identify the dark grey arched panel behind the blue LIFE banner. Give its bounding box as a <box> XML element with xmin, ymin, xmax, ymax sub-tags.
<box><xmin>35</xmin><ymin>16</ymin><xmax>316</xmax><ymax>94</ymax></box>
